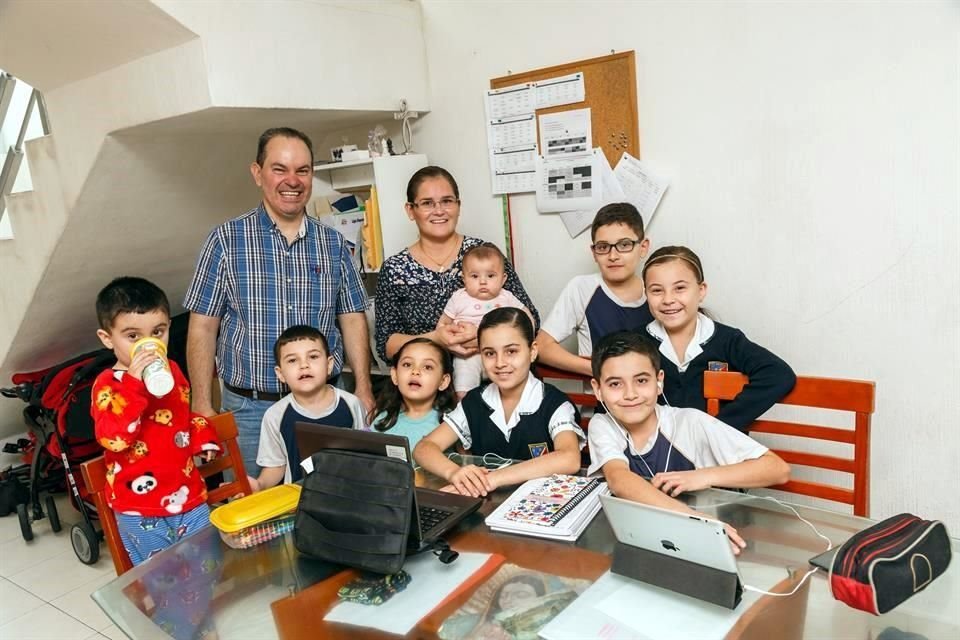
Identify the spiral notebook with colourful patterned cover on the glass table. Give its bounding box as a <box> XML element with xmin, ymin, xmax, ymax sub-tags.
<box><xmin>485</xmin><ymin>474</ymin><xmax>609</xmax><ymax>541</ymax></box>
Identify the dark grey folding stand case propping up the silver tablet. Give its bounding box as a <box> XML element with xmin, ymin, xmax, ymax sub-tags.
<box><xmin>610</xmin><ymin>542</ymin><xmax>743</xmax><ymax>609</ymax></box>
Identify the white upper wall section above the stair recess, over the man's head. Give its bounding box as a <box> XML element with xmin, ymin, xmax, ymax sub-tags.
<box><xmin>154</xmin><ymin>0</ymin><xmax>427</xmax><ymax>110</ymax></box>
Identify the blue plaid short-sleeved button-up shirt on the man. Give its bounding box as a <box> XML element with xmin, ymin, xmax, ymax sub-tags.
<box><xmin>183</xmin><ymin>203</ymin><xmax>367</xmax><ymax>393</ymax></box>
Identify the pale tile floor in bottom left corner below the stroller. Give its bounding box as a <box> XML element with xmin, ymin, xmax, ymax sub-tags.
<box><xmin>0</xmin><ymin>461</ymin><xmax>126</xmax><ymax>640</ymax></box>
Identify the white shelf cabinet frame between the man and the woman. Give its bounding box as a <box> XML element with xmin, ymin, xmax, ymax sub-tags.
<box><xmin>313</xmin><ymin>154</ymin><xmax>427</xmax><ymax>258</ymax></box>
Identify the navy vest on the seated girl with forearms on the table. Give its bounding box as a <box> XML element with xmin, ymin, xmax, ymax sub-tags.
<box><xmin>461</xmin><ymin>383</ymin><xmax>580</xmax><ymax>460</ymax></box>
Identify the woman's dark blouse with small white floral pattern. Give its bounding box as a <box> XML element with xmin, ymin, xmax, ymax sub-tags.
<box><xmin>375</xmin><ymin>236</ymin><xmax>540</xmax><ymax>362</ymax></box>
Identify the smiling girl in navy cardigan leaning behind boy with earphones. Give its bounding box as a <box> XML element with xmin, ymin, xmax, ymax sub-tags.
<box><xmin>643</xmin><ymin>246</ymin><xmax>797</xmax><ymax>432</ymax></box>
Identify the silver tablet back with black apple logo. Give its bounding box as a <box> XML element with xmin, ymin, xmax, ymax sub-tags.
<box><xmin>600</xmin><ymin>496</ymin><xmax>738</xmax><ymax>573</ymax></box>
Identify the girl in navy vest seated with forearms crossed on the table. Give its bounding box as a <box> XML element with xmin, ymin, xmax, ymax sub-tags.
<box><xmin>413</xmin><ymin>307</ymin><xmax>584</xmax><ymax>497</ymax></box>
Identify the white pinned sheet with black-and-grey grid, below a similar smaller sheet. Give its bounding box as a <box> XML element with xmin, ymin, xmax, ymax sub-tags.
<box><xmin>536</xmin><ymin>150</ymin><xmax>603</xmax><ymax>213</ymax></box>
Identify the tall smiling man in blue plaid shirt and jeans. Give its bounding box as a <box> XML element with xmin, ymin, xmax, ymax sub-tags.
<box><xmin>184</xmin><ymin>127</ymin><xmax>373</xmax><ymax>477</ymax></box>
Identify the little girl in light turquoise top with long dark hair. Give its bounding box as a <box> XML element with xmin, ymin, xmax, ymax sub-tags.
<box><xmin>371</xmin><ymin>338</ymin><xmax>457</xmax><ymax>450</ymax></box>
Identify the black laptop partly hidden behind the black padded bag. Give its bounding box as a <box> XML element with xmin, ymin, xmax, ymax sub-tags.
<box><xmin>293</xmin><ymin>422</ymin><xmax>483</xmax><ymax>550</ymax></box>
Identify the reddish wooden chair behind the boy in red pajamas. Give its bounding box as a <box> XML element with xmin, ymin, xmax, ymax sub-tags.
<box><xmin>80</xmin><ymin>413</ymin><xmax>253</xmax><ymax>576</ymax></box>
